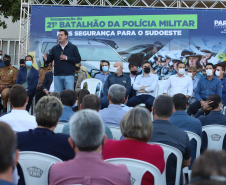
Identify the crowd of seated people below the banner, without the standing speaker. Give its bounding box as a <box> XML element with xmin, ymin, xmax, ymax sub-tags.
<box><xmin>0</xmin><ymin>48</ymin><xmax>226</xmax><ymax>185</ymax></box>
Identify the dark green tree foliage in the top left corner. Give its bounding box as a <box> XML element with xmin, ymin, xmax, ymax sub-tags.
<box><xmin>0</xmin><ymin>0</ymin><xmax>21</xmax><ymax>29</ymax></box>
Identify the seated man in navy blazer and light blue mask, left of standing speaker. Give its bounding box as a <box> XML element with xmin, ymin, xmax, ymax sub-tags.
<box><xmin>16</xmin><ymin>55</ymin><xmax>39</xmax><ymax>111</ymax></box>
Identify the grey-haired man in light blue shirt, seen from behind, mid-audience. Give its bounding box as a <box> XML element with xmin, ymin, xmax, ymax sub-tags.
<box><xmin>100</xmin><ymin>84</ymin><xmax>126</xmax><ymax>127</ymax></box>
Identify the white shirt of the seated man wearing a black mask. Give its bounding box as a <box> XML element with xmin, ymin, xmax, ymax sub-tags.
<box><xmin>133</xmin><ymin>73</ymin><xmax>158</xmax><ymax>97</ymax></box>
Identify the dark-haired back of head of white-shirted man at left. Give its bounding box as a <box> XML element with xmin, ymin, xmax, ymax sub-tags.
<box><xmin>9</xmin><ymin>84</ymin><xmax>27</xmax><ymax>108</ymax></box>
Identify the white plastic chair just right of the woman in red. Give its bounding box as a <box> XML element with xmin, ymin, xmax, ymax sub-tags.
<box><xmin>148</xmin><ymin>142</ymin><xmax>183</xmax><ymax>185</ymax></box>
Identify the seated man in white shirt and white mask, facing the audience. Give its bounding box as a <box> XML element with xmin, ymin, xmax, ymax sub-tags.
<box><xmin>163</xmin><ymin>62</ymin><xmax>193</xmax><ymax>99</ymax></box>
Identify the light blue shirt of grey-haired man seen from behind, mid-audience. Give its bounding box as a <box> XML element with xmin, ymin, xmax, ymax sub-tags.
<box><xmin>100</xmin><ymin>104</ymin><xmax>126</xmax><ymax>127</ymax></box>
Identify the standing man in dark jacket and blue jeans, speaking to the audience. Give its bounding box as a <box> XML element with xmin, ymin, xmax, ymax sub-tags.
<box><xmin>43</xmin><ymin>29</ymin><xmax>81</xmax><ymax>93</ymax></box>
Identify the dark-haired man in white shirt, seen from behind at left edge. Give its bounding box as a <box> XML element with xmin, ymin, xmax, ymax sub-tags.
<box><xmin>0</xmin><ymin>84</ymin><xmax>37</xmax><ymax>132</ymax></box>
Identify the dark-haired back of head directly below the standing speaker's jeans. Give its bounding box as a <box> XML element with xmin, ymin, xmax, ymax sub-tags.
<box><xmin>60</xmin><ymin>89</ymin><xmax>76</xmax><ymax>107</ymax></box>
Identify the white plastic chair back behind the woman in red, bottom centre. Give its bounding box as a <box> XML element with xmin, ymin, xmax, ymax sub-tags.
<box><xmin>105</xmin><ymin>158</ymin><xmax>164</xmax><ymax>185</ymax></box>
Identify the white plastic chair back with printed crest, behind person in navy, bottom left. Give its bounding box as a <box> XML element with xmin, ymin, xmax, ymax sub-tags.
<box><xmin>18</xmin><ymin>151</ymin><xmax>62</xmax><ymax>185</ymax></box>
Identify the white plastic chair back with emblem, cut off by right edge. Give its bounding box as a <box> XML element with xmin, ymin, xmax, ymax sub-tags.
<box><xmin>202</xmin><ymin>125</ymin><xmax>226</xmax><ymax>151</ymax></box>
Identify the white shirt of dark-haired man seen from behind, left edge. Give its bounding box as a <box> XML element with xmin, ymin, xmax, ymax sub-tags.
<box><xmin>0</xmin><ymin>109</ymin><xmax>37</xmax><ymax>132</ymax></box>
